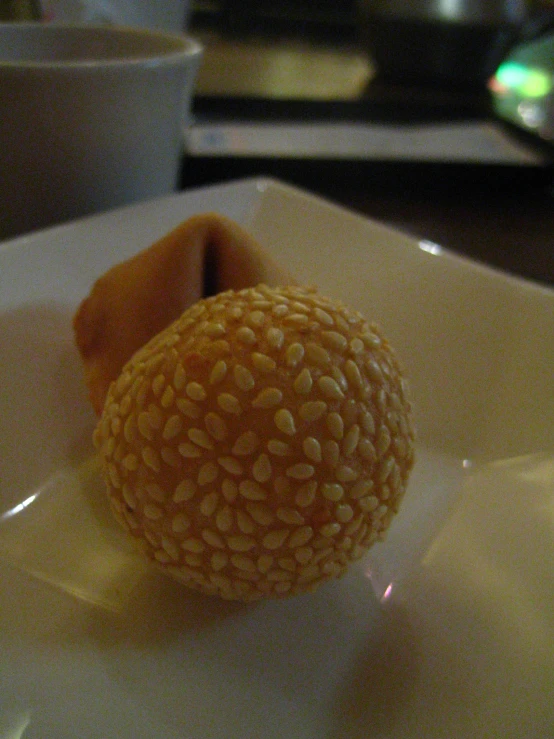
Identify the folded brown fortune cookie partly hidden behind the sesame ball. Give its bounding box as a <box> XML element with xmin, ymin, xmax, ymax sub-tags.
<box><xmin>73</xmin><ymin>213</ymin><xmax>293</xmax><ymax>415</ymax></box>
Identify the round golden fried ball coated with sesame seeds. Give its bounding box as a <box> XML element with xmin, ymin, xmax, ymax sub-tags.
<box><xmin>94</xmin><ymin>285</ymin><xmax>414</xmax><ymax>600</ymax></box>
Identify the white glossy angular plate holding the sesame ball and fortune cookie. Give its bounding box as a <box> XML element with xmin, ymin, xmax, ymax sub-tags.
<box><xmin>0</xmin><ymin>179</ymin><xmax>554</xmax><ymax>739</ymax></box>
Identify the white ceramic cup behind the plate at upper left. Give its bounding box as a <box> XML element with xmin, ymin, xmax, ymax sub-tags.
<box><xmin>0</xmin><ymin>23</ymin><xmax>202</xmax><ymax>238</ymax></box>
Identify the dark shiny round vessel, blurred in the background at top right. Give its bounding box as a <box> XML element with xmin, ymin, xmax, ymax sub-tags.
<box><xmin>358</xmin><ymin>0</ymin><xmax>527</xmax><ymax>85</ymax></box>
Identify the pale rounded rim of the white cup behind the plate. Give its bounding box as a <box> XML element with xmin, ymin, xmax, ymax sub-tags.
<box><xmin>0</xmin><ymin>21</ymin><xmax>204</xmax><ymax>71</ymax></box>
